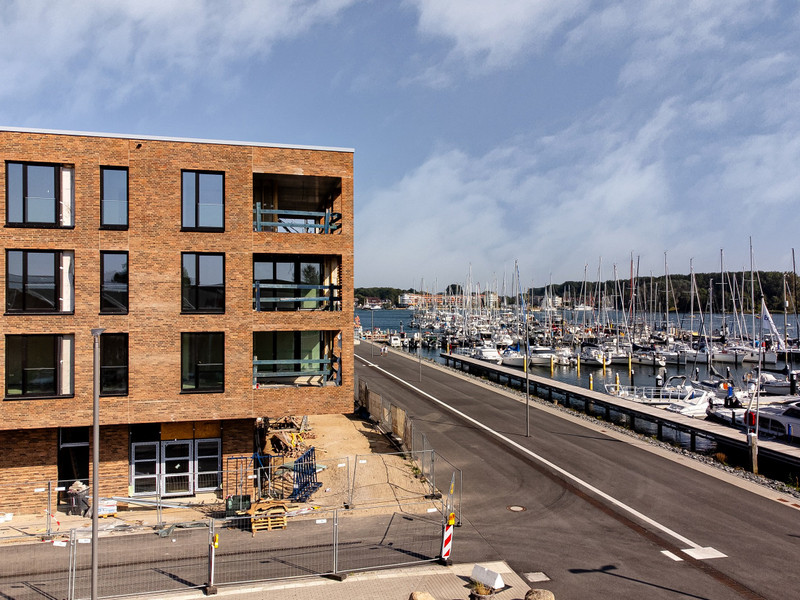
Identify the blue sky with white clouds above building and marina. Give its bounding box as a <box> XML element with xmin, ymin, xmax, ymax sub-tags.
<box><xmin>0</xmin><ymin>0</ymin><xmax>800</xmax><ymax>291</ymax></box>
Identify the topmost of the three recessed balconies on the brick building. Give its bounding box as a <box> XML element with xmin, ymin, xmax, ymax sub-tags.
<box><xmin>253</xmin><ymin>173</ymin><xmax>342</xmax><ymax>234</ymax></box>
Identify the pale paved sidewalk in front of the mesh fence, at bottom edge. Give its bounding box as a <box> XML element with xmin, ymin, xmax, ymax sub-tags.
<box><xmin>131</xmin><ymin>561</ymin><xmax>531</xmax><ymax>600</ymax></box>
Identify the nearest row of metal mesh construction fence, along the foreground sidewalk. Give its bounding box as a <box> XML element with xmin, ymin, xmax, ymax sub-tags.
<box><xmin>0</xmin><ymin>502</ymin><xmax>444</xmax><ymax>600</ymax></box>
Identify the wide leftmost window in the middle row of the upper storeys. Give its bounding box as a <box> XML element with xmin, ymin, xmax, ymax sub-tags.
<box><xmin>6</xmin><ymin>250</ymin><xmax>75</xmax><ymax>313</ymax></box>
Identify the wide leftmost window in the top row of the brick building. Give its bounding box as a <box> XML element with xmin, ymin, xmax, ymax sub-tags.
<box><xmin>6</xmin><ymin>162</ymin><xmax>75</xmax><ymax>227</ymax></box>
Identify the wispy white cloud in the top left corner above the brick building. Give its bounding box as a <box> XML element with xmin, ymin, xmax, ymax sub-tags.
<box><xmin>0</xmin><ymin>0</ymin><xmax>359</xmax><ymax>110</ymax></box>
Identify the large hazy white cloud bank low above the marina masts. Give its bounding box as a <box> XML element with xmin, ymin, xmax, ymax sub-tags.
<box><xmin>356</xmin><ymin>60</ymin><xmax>800</xmax><ymax>287</ymax></box>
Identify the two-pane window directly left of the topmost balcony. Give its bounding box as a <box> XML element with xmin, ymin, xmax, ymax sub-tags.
<box><xmin>181</xmin><ymin>171</ymin><xmax>225</xmax><ymax>231</ymax></box>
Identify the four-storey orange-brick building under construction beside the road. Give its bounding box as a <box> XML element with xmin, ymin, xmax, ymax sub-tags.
<box><xmin>0</xmin><ymin>128</ymin><xmax>353</xmax><ymax>512</ymax></box>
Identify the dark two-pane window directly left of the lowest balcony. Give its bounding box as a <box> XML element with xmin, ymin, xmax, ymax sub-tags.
<box><xmin>181</xmin><ymin>333</ymin><xmax>220</xmax><ymax>392</ymax></box>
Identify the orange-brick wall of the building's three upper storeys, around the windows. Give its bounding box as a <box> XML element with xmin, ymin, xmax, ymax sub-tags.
<box><xmin>0</xmin><ymin>131</ymin><xmax>353</xmax><ymax>432</ymax></box>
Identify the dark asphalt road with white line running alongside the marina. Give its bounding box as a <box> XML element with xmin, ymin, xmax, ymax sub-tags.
<box><xmin>356</xmin><ymin>343</ymin><xmax>800</xmax><ymax>600</ymax></box>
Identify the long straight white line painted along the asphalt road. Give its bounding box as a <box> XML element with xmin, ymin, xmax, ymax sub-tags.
<box><xmin>357</xmin><ymin>356</ymin><xmax>725</xmax><ymax>560</ymax></box>
